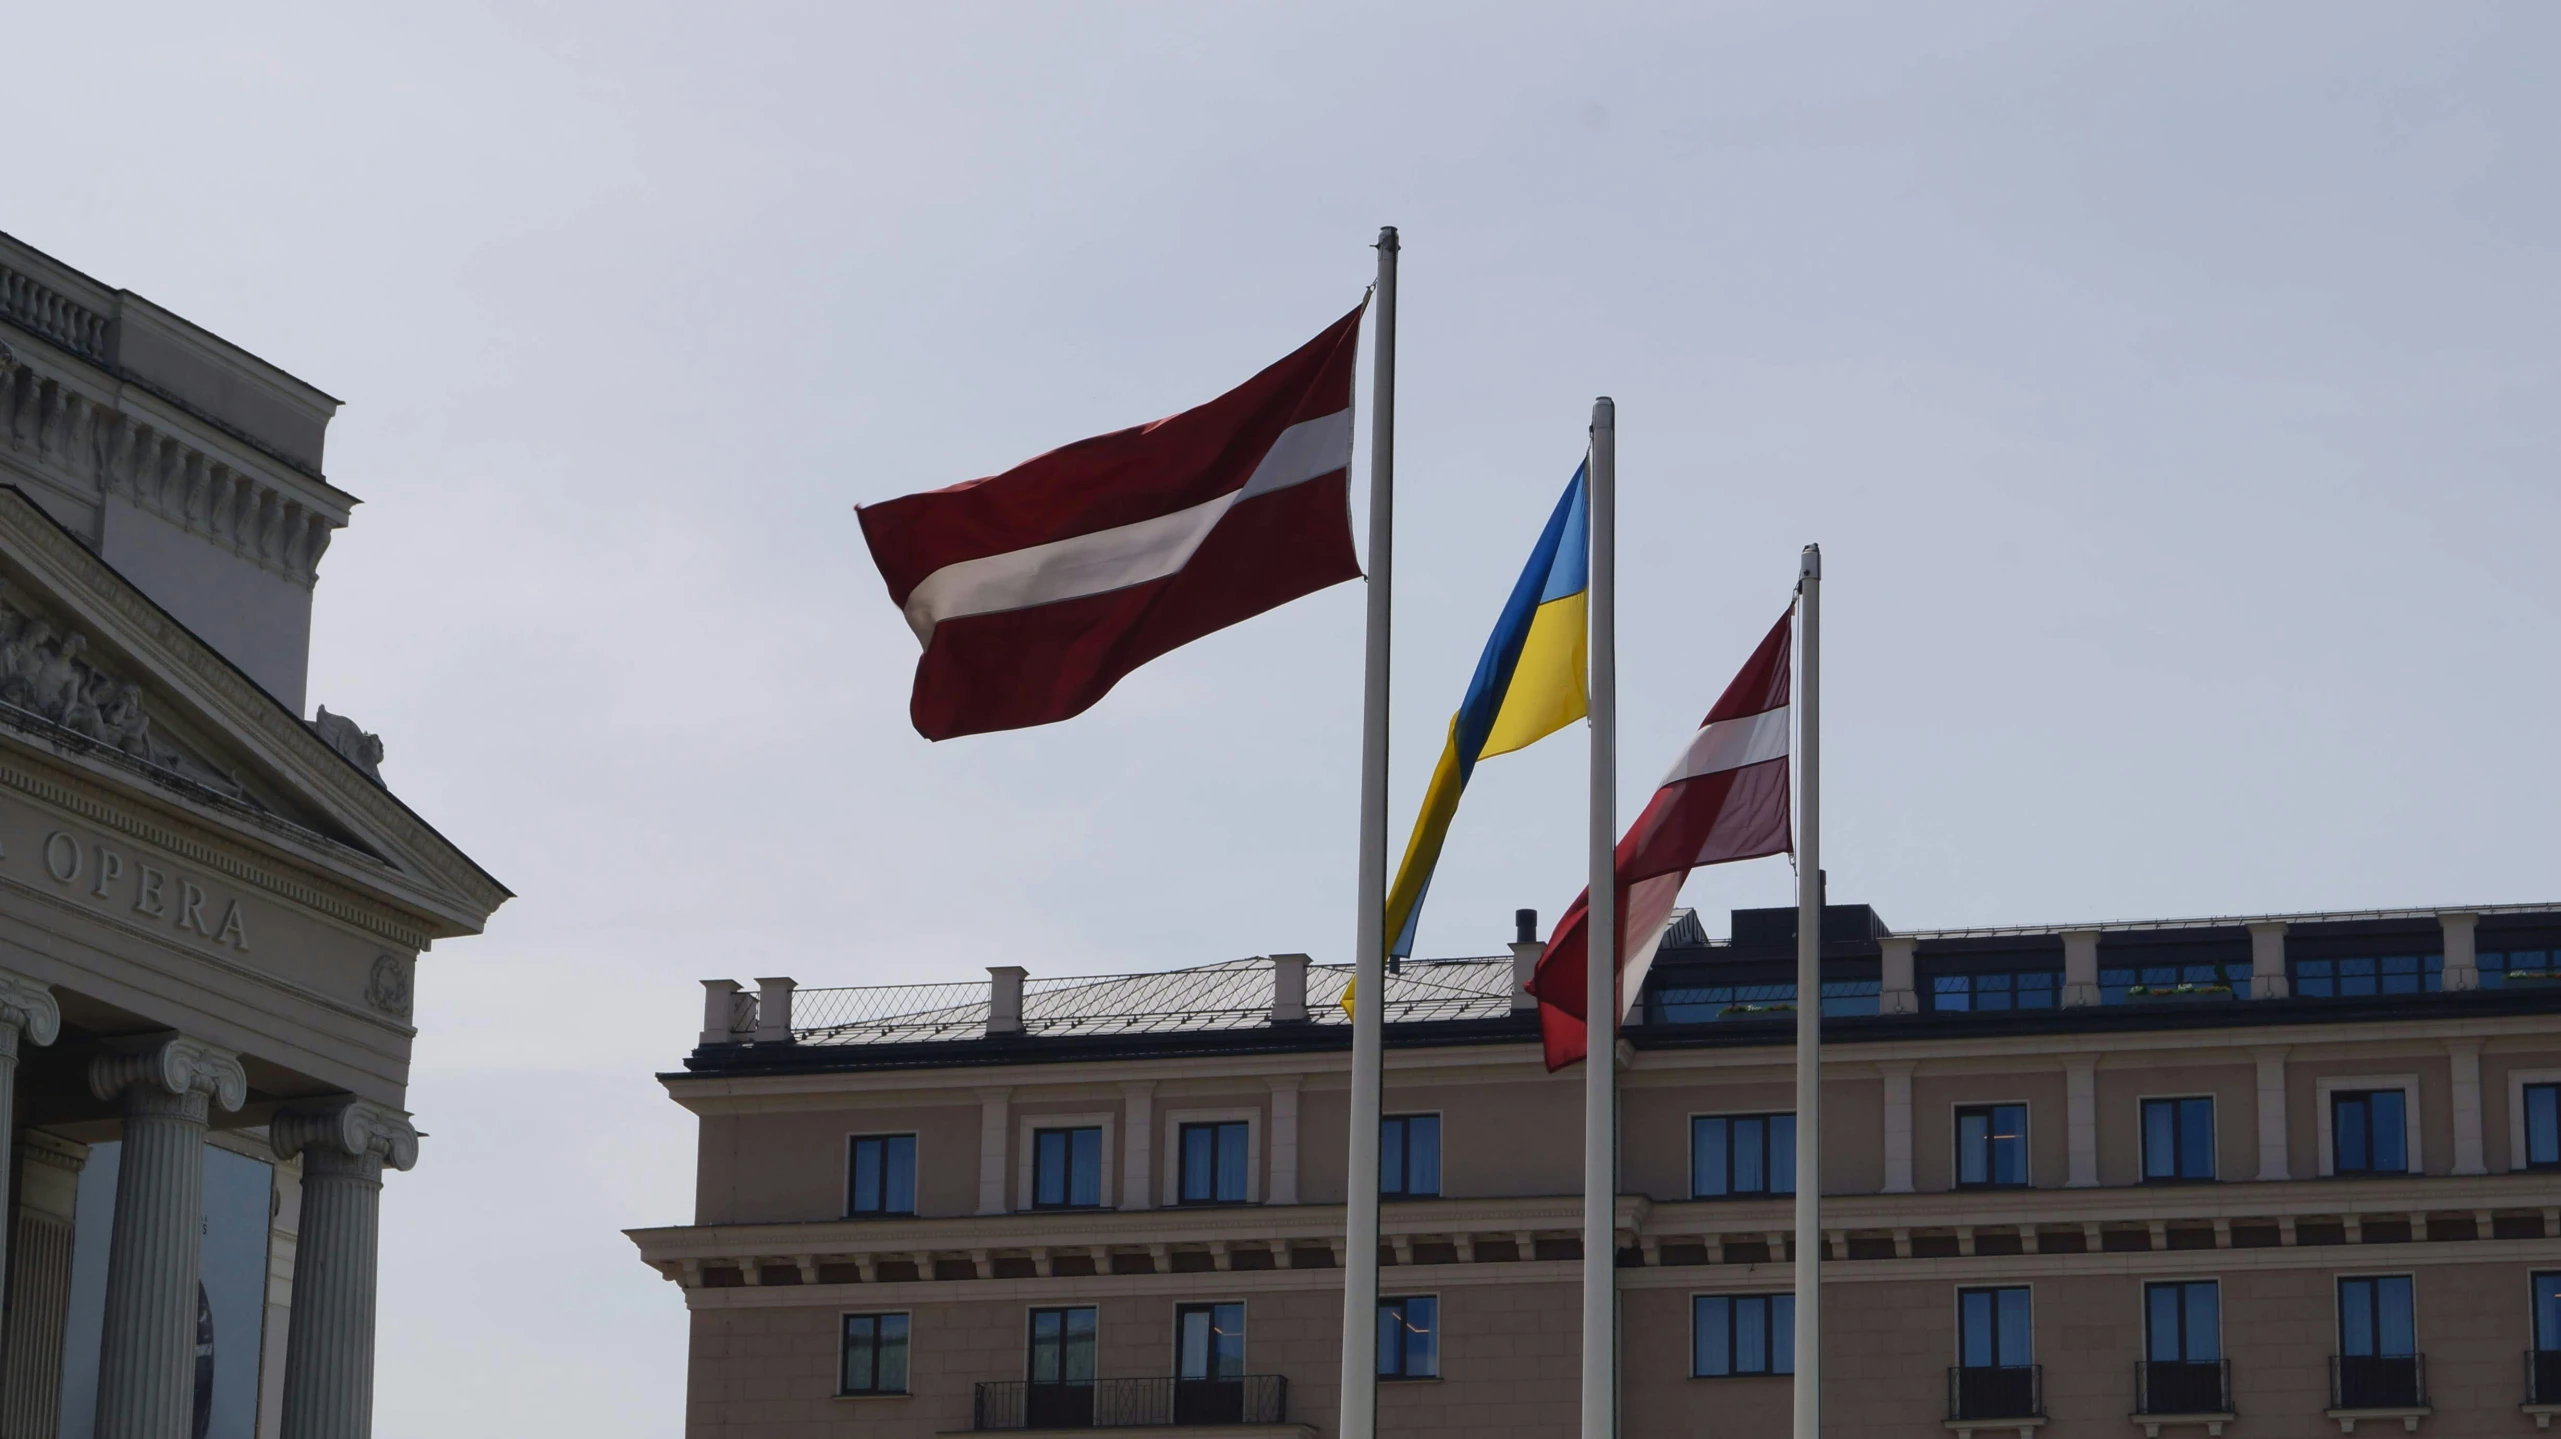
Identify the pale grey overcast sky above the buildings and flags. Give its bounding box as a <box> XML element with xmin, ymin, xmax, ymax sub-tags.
<box><xmin>20</xmin><ymin>0</ymin><xmax>2561</xmax><ymax>1439</ymax></box>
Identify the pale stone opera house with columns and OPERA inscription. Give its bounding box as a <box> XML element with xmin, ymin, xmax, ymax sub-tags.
<box><xmin>0</xmin><ymin>236</ymin><xmax>507</xmax><ymax>1439</ymax></box>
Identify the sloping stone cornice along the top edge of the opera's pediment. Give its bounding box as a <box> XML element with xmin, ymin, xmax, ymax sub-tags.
<box><xmin>0</xmin><ymin>489</ymin><xmax>512</xmax><ymax>937</ymax></box>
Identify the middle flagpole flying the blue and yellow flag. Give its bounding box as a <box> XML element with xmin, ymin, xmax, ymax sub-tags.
<box><xmin>1583</xmin><ymin>397</ymin><xmax>1619</xmax><ymax>1439</ymax></box>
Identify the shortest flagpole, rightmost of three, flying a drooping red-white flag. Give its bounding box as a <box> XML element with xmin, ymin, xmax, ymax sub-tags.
<box><xmin>1795</xmin><ymin>545</ymin><xmax>1823</xmax><ymax>1439</ymax></box>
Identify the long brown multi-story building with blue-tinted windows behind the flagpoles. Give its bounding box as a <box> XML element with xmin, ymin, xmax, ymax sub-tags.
<box><xmin>633</xmin><ymin>904</ymin><xmax>2561</xmax><ymax>1439</ymax></box>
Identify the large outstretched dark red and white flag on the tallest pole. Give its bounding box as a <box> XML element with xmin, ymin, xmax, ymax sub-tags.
<box><xmin>858</xmin><ymin>302</ymin><xmax>1368</xmax><ymax>740</ymax></box>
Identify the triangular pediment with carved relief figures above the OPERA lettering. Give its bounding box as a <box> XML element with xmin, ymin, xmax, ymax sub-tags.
<box><xmin>0</xmin><ymin>486</ymin><xmax>510</xmax><ymax>940</ymax></box>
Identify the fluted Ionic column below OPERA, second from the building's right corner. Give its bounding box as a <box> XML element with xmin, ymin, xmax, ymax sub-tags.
<box><xmin>90</xmin><ymin>1034</ymin><xmax>248</xmax><ymax>1439</ymax></box>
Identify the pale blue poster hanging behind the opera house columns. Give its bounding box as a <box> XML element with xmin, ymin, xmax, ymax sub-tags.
<box><xmin>61</xmin><ymin>1142</ymin><xmax>284</xmax><ymax>1439</ymax></box>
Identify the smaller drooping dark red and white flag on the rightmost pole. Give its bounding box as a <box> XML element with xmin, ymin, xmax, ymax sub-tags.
<box><xmin>1529</xmin><ymin>607</ymin><xmax>1795</xmax><ymax>1070</ymax></box>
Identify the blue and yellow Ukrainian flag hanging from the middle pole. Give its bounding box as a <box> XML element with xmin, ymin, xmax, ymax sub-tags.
<box><xmin>1388</xmin><ymin>469</ymin><xmax>1590</xmax><ymax>958</ymax></box>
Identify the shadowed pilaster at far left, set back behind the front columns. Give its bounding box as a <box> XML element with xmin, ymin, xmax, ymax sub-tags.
<box><xmin>0</xmin><ymin>1129</ymin><xmax>90</xmax><ymax>1439</ymax></box>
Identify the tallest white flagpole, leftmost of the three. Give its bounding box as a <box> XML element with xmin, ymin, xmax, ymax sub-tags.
<box><xmin>1339</xmin><ymin>225</ymin><xmax>1396</xmax><ymax>1439</ymax></box>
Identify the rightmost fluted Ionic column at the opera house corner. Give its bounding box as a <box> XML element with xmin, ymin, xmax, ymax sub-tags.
<box><xmin>266</xmin><ymin>1096</ymin><xmax>417</xmax><ymax>1439</ymax></box>
